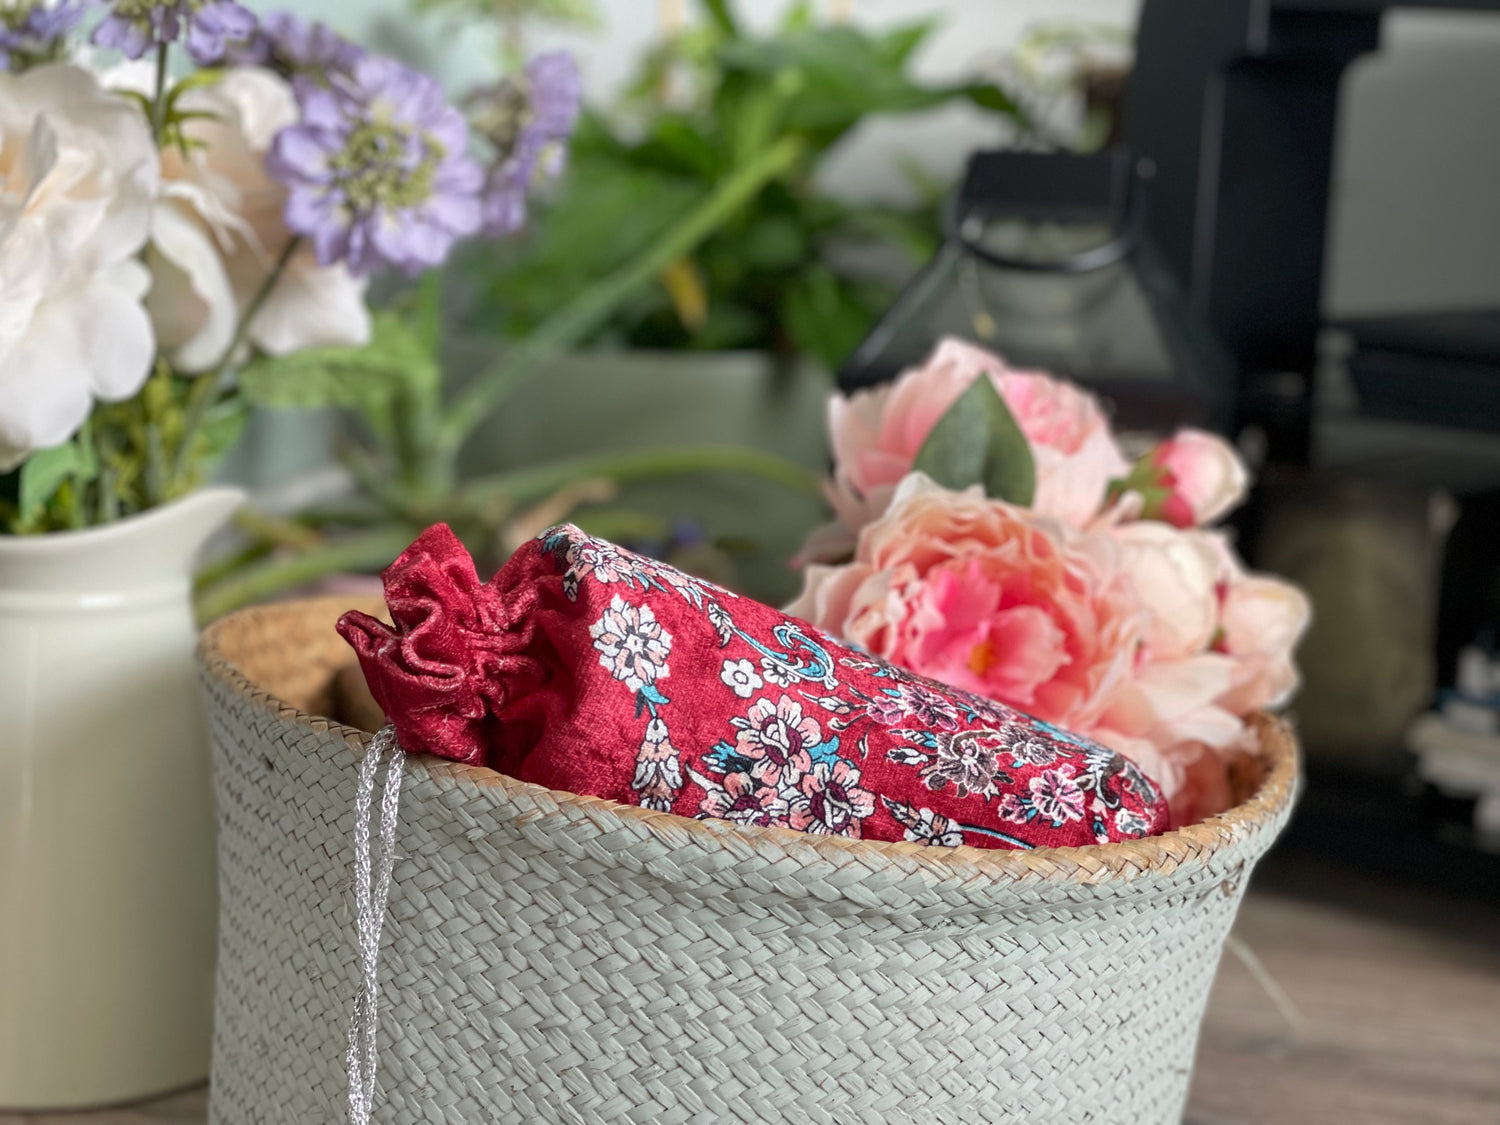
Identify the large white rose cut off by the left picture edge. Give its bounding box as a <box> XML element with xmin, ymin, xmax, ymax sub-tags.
<box><xmin>0</xmin><ymin>65</ymin><xmax>158</xmax><ymax>470</ymax></box>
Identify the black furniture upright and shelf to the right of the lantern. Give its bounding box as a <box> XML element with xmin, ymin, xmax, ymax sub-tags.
<box><xmin>1124</xmin><ymin>0</ymin><xmax>1500</xmax><ymax>464</ymax></box>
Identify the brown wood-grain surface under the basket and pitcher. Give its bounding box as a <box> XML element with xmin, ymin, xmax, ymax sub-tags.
<box><xmin>11</xmin><ymin>869</ymin><xmax>1500</xmax><ymax>1125</ymax></box>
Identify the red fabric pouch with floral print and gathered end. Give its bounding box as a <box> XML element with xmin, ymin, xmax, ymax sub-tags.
<box><xmin>339</xmin><ymin>525</ymin><xmax>1167</xmax><ymax>848</ymax></box>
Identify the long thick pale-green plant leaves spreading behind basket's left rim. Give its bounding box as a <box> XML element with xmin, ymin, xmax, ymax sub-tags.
<box><xmin>198</xmin><ymin>138</ymin><xmax>818</xmax><ymax>618</ymax></box>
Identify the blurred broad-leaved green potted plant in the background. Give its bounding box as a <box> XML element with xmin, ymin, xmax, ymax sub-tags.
<box><xmin>465</xmin><ymin>0</ymin><xmax>1020</xmax><ymax>368</ymax></box>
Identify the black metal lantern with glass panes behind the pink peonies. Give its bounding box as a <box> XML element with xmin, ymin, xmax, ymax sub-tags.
<box><xmin>839</xmin><ymin>149</ymin><xmax>1233</xmax><ymax>431</ymax></box>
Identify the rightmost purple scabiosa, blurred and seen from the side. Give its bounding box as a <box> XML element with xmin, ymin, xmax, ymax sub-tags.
<box><xmin>470</xmin><ymin>51</ymin><xmax>581</xmax><ymax>234</ymax></box>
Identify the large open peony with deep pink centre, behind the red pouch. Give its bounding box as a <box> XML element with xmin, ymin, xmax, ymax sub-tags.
<box><xmin>789</xmin><ymin>473</ymin><xmax>1142</xmax><ymax>732</ymax></box>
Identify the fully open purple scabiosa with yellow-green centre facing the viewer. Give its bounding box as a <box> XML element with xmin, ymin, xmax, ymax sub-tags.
<box><xmin>266</xmin><ymin>54</ymin><xmax>483</xmax><ymax>275</ymax></box>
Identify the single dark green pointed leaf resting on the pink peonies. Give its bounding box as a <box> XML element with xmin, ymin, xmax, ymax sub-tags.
<box><xmin>912</xmin><ymin>375</ymin><xmax>1037</xmax><ymax>506</ymax></box>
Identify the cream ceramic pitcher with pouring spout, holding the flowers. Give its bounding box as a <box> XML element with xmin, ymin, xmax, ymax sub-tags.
<box><xmin>0</xmin><ymin>488</ymin><xmax>243</xmax><ymax>1113</ymax></box>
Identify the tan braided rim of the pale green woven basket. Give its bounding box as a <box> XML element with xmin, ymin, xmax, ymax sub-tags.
<box><xmin>198</xmin><ymin>596</ymin><xmax>1301</xmax><ymax>884</ymax></box>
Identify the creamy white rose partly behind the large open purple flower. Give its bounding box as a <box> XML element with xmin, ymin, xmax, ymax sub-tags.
<box><xmin>141</xmin><ymin>68</ymin><xmax>371</xmax><ymax>372</ymax></box>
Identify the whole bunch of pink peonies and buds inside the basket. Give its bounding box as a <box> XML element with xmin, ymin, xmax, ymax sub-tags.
<box><xmin>791</xmin><ymin>341</ymin><xmax>1310</xmax><ymax>824</ymax></box>
